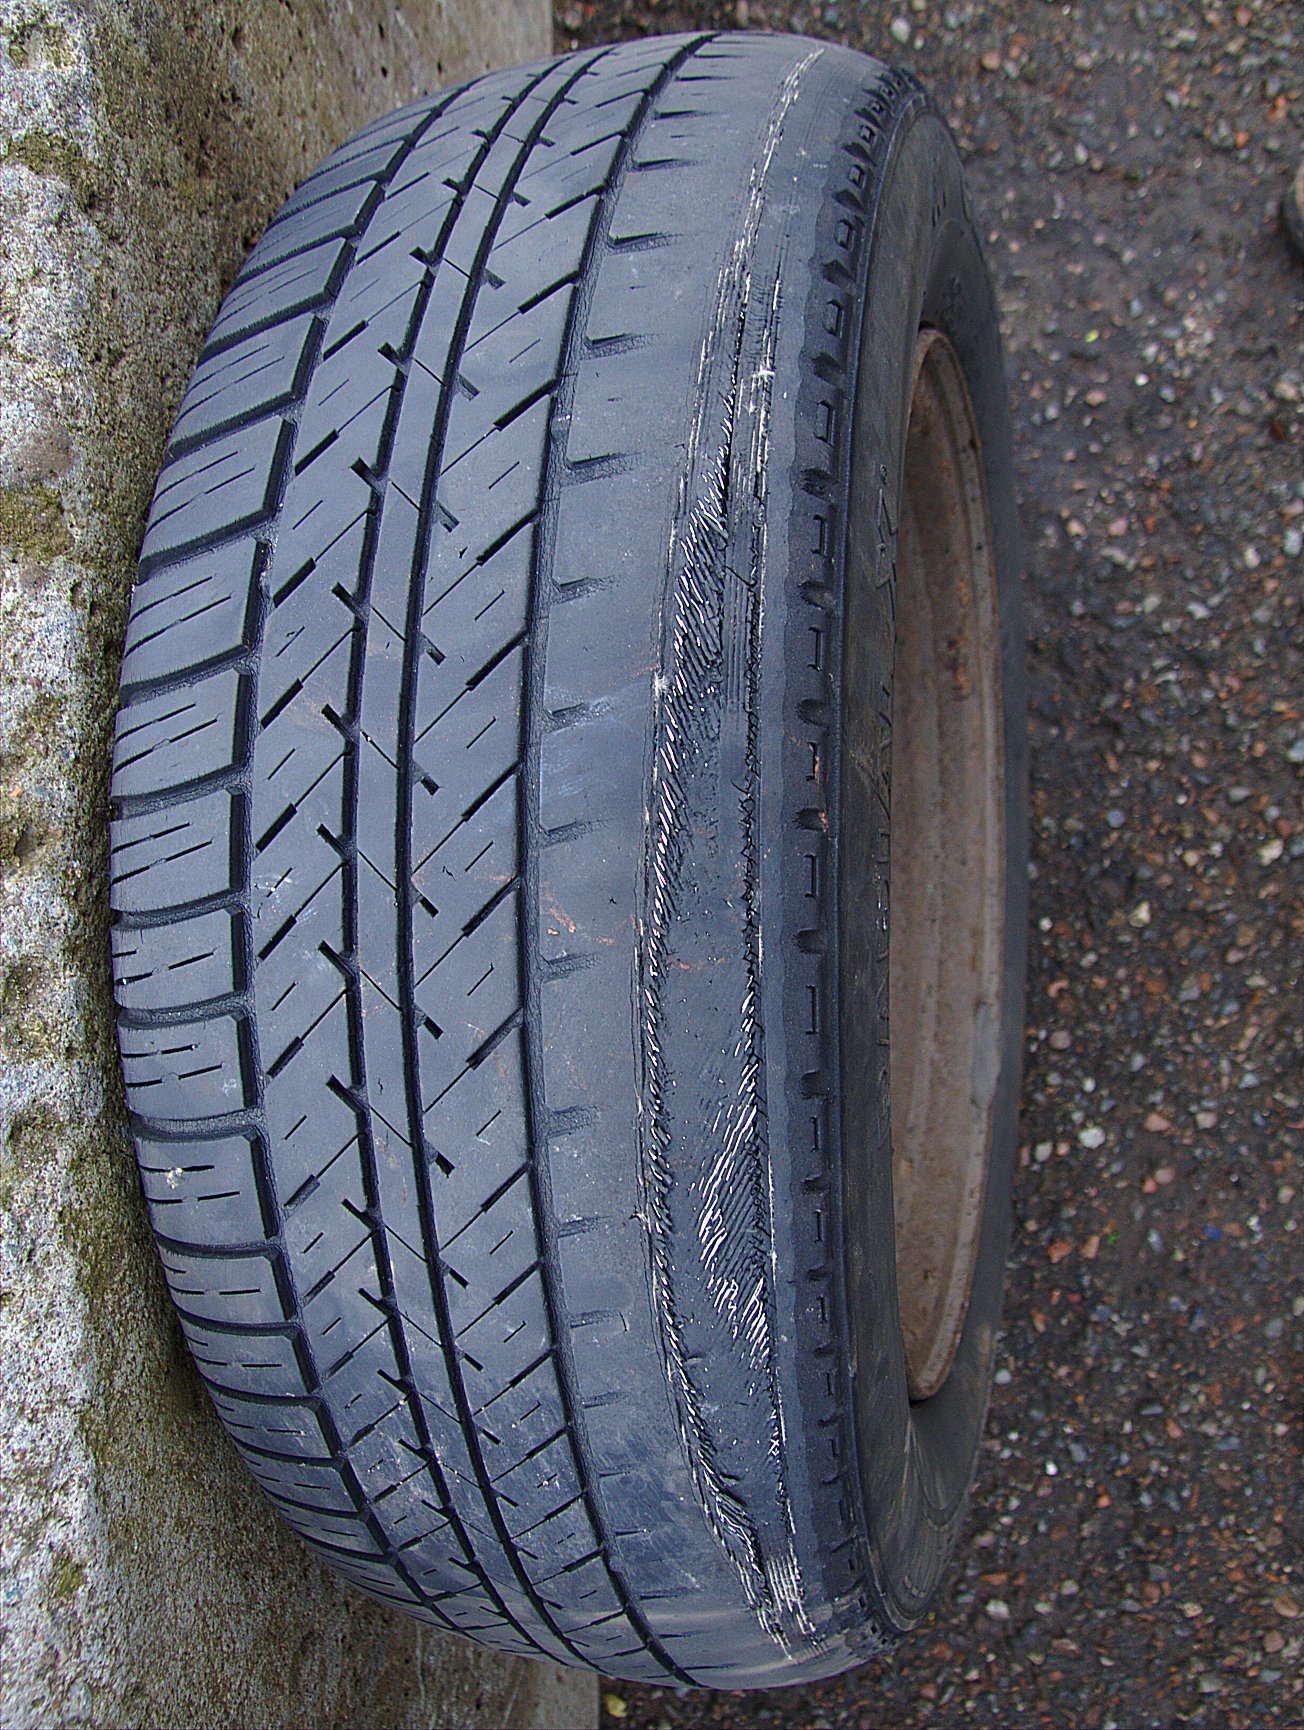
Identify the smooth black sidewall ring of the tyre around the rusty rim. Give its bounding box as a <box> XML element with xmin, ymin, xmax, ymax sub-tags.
<box><xmin>837</xmin><ymin>102</ymin><xmax>1027</xmax><ymax>1630</ymax></box>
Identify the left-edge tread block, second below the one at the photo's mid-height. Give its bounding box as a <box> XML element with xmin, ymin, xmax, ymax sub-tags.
<box><xmin>118</xmin><ymin>1016</ymin><xmax>252</xmax><ymax>1121</ymax></box>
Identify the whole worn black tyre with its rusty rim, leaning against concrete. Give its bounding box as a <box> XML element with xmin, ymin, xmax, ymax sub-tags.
<box><xmin>111</xmin><ymin>35</ymin><xmax>1026</xmax><ymax>1687</ymax></box>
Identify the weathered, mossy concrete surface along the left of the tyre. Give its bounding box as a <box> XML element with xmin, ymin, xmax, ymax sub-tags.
<box><xmin>0</xmin><ymin>0</ymin><xmax>595</xmax><ymax>1730</ymax></box>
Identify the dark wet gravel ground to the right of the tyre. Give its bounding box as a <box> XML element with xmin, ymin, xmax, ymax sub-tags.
<box><xmin>557</xmin><ymin>0</ymin><xmax>1304</xmax><ymax>1730</ymax></box>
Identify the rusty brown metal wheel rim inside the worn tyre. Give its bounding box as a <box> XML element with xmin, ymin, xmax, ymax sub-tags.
<box><xmin>887</xmin><ymin>329</ymin><xmax>1005</xmax><ymax>1400</ymax></box>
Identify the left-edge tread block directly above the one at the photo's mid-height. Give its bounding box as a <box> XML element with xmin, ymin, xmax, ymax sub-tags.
<box><xmin>112</xmin><ymin>670</ymin><xmax>246</xmax><ymax>799</ymax></box>
